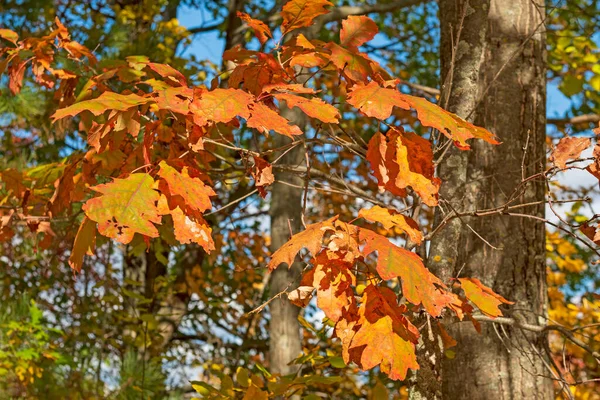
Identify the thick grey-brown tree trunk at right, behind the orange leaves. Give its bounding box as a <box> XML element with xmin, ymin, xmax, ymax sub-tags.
<box><xmin>417</xmin><ymin>0</ymin><xmax>553</xmax><ymax>399</ymax></box>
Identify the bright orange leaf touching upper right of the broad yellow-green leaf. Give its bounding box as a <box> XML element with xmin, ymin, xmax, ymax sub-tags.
<box><xmin>158</xmin><ymin>161</ymin><xmax>215</xmax><ymax>213</ymax></box>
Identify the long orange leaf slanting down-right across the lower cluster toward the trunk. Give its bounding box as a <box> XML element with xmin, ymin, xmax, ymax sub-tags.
<box><xmin>359</xmin><ymin>228</ymin><xmax>454</xmax><ymax>317</ymax></box>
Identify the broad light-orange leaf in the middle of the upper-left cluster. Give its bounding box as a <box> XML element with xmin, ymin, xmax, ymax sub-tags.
<box><xmin>190</xmin><ymin>88</ymin><xmax>254</xmax><ymax>126</ymax></box>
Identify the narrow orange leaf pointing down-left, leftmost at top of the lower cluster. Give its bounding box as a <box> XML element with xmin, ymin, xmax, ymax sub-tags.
<box><xmin>267</xmin><ymin>217</ymin><xmax>337</xmax><ymax>271</ymax></box>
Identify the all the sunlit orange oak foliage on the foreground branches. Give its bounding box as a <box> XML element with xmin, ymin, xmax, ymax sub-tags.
<box><xmin>0</xmin><ymin>0</ymin><xmax>600</xmax><ymax>390</ymax></box>
